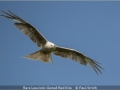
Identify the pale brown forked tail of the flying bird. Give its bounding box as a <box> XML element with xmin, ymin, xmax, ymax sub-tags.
<box><xmin>23</xmin><ymin>50</ymin><xmax>53</xmax><ymax>64</ymax></box>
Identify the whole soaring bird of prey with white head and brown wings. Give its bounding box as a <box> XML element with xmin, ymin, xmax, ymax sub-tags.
<box><xmin>0</xmin><ymin>10</ymin><xmax>104</xmax><ymax>74</ymax></box>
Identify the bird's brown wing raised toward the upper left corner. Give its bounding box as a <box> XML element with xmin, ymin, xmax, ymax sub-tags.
<box><xmin>0</xmin><ymin>10</ymin><xmax>47</xmax><ymax>47</ymax></box>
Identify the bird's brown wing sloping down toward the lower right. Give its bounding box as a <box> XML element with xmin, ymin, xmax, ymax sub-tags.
<box><xmin>53</xmin><ymin>46</ymin><xmax>104</xmax><ymax>74</ymax></box>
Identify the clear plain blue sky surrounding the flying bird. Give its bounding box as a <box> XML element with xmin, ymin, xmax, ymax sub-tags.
<box><xmin>0</xmin><ymin>1</ymin><xmax>120</xmax><ymax>85</ymax></box>
